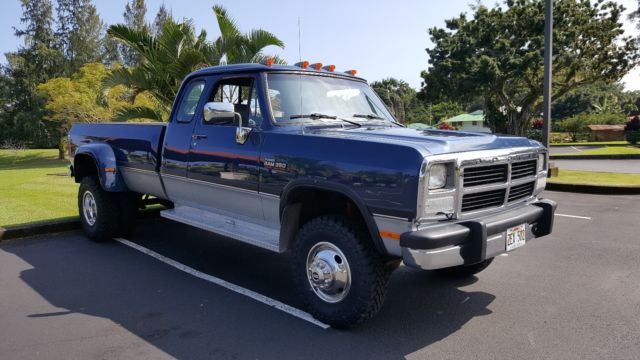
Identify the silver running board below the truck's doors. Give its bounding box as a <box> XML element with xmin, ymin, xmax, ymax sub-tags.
<box><xmin>160</xmin><ymin>205</ymin><xmax>281</xmax><ymax>252</ymax></box>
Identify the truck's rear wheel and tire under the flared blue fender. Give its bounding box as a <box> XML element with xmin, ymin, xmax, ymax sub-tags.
<box><xmin>78</xmin><ymin>176</ymin><xmax>119</xmax><ymax>242</ymax></box>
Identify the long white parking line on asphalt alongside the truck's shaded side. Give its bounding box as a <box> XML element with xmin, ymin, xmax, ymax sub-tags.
<box><xmin>114</xmin><ymin>238</ymin><xmax>331</xmax><ymax>329</ymax></box>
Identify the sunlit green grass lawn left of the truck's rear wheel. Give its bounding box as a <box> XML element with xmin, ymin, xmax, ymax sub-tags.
<box><xmin>0</xmin><ymin>149</ymin><xmax>78</xmax><ymax>227</ymax></box>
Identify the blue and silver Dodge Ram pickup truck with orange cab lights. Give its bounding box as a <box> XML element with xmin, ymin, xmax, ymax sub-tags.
<box><xmin>69</xmin><ymin>62</ymin><xmax>556</xmax><ymax>327</ymax></box>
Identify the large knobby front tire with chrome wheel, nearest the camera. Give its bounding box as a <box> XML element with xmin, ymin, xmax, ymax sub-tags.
<box><xmin>292</xmin><ymin>216</ymin><xmax>390</xmax><ymax>328</ymax></box>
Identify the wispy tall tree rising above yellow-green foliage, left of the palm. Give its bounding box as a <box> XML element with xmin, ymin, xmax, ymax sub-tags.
<box><xmin>56</xmin><ymin>0</ymin><xmax>105</xmax><ymax>75</ymax></box>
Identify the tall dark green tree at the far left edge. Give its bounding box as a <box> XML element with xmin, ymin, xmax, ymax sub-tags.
<box><xmin>0</xmin><ymin>0</ymin><xmax>61</xmax><ymax>146</ymax></box>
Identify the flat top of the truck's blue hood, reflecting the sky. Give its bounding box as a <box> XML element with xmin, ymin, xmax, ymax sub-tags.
<box><xmin>305</xmin><ymin>126</ymin><xmax>542</xmax><ymax>155</ymax></box>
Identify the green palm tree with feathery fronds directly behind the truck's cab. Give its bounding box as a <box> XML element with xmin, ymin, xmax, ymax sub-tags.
<box><xmin>104</xmin><ymin>5</ymin><xmax>284</xmax><ymax>121</ymax></box>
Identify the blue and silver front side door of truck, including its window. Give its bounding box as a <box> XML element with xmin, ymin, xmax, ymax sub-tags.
<box><xmin>187</xmin><ymin>75</ymin><xmax>263</xmax><ymax>221</ymax></box>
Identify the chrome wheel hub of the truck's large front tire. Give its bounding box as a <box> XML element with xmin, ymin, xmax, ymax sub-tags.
<box><xmin>307</xmin><ymin>242</ymin><xmax>351</xmax><ymax>303</ymax></box>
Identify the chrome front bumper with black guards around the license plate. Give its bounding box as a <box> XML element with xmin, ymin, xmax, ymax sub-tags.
<box><xmin>400</xmin><ymin>200</ymin><xmax>557</xmax><ymax>270</ymax></box>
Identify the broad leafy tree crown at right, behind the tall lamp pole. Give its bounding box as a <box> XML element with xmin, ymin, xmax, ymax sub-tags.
<box><xmin>422</xmin><ymin>0</ymin><xmax>638</xmax><ymax>135</ymax></box>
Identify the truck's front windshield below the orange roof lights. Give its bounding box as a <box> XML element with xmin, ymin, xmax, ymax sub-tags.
<box><xmin>267</xmin><ymin>74</ymin><xmax>395</xmax><ymax>125</ymax></box>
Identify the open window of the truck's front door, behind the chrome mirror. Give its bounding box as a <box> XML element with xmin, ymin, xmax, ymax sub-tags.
<box><xmin>209</xmin><ymin>78</ymin><xmax>262</xmax><ymax>127</ymax></box>
